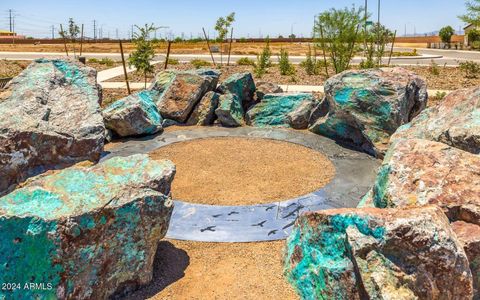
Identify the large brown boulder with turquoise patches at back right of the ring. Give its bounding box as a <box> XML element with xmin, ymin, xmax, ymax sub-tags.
<box><xmin>310</xmin><ymin>68</ymin><xmax>428</xmax><ymax>156</ymax></box>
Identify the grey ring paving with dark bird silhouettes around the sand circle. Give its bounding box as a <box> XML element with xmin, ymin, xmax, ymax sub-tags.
<box><xmin>101</xmin><ymin>127</ymin><xmax>381</xmax><ymax>242</ymax></box>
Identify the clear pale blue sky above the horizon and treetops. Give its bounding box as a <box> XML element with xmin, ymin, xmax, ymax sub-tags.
<box><xmin>0</xmin><ymin>0</ymin><xmax>465</xmax><ymax>38</ymax></box>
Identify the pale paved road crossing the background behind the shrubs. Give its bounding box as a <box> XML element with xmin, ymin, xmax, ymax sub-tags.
<box><xmin>0</xmin><ymin>48</ymin><xmax>480</xmax><ymax>66</ymax></box>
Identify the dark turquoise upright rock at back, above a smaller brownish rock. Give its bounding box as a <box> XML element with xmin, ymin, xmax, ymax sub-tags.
<box><xmin>218</xmin><ymin>73</ymin><xmax>256</xmax><ymax>111</ymax></box>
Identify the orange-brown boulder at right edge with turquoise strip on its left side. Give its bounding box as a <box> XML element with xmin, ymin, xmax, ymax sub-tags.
<box><xmin>373</xmin><ymin>139</ymin><xmax>480</xmax><ymax>225</ymax></box>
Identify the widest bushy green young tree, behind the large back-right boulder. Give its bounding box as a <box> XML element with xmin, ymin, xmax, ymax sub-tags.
<box><xmin>314</xmin><ymin>6</ymin><xmax>365</xmax><ymax>74</ymax></box>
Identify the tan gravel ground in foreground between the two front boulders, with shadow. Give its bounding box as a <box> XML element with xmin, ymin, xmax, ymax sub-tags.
<box><xmin>122</xmin><ymin>240</ymin><xmax>299</xmax><ymax>300</ymax></box>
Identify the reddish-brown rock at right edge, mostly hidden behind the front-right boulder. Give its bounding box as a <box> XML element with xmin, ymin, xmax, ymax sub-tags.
<box><xmin>452</xmin><ymin>221</ymin><xmax>480</xmax><ymax>299</ymax></box>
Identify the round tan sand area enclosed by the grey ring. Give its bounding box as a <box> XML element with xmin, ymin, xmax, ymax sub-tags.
<box><xmin>150</xmin><ymin>137</ymin><xmax>335</xmax><ymax>205</ymax></box>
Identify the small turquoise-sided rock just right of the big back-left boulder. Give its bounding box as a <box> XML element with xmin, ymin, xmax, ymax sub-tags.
<box><xmin>102</xmin><ymin>90</ymin><xmax>163</xmax><ymax>137</ymax></box>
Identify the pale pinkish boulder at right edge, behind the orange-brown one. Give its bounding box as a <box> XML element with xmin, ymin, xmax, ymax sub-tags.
<box><xmin>392</xmin><ymin>88</ymin><xmax>480</xmax><ymax>154</ymax></box>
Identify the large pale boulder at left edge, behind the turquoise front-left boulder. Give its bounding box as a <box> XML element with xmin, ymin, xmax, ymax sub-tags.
<box><xmin>0</xmin><ymin>59</ymin><xmax>105</xmax><ymax>195</ymax></box>
